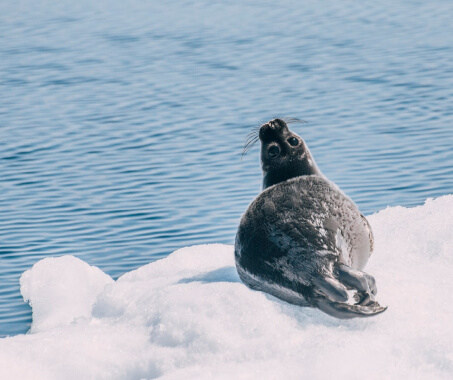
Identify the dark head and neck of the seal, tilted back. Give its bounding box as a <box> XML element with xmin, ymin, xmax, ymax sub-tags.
<box><xmin>259</xmin><ymin>119</ymin><xmax>321</xmax><ymax>189</ymax></box>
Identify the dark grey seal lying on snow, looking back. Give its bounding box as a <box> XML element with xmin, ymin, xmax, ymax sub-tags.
<box><xmin>235</xmin><ymin>119</ymin><xmax>387</xmax><ymax>319</ymax></box>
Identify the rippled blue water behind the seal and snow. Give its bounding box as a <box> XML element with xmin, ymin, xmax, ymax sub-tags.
<box><xmin>0</xmin><ymin>0</ymin><xmax>453</xmax><ymax>336</ymax></box>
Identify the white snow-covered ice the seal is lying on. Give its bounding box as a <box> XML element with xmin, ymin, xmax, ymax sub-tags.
<box><xmin>0</xmin><ymin>195</ymin><xmax>453</xmax><ymax>380</ymax></box>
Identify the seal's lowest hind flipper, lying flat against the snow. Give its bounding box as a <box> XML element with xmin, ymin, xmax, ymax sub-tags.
<box><xmin>316</xmin><ymin>298</ymin><xmax>387</xmax><ymax>319</ymax></box>
